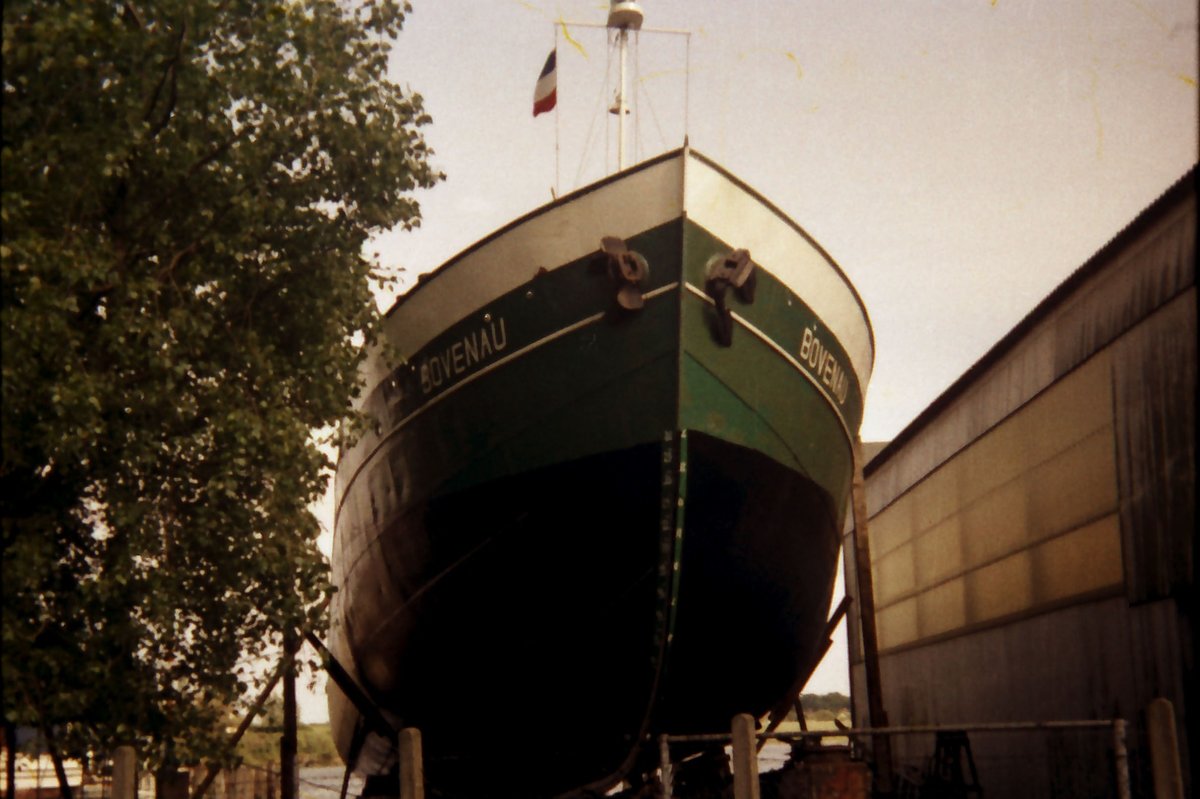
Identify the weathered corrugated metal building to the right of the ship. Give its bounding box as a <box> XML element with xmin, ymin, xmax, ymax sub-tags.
<box><xmin>845</xmin><ymin>169</ymin><xmax>1200</xmax><ymax>798</ymax></box>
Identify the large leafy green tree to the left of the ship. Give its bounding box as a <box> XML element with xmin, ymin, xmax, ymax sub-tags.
<box><xmin>0</xmin><ymin>0</ymin><xmax>440</xmax><ymax>782</ymax></box>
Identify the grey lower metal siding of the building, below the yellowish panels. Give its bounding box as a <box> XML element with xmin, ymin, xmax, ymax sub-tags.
<box><xmin>851</xmin><ymin>596</ymin><xmax>1194</xmax><ymax>799</ymax></box>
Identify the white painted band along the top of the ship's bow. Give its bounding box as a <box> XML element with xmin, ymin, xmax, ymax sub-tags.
<box><xmin>364</xmin><ymin>150</ymin><xmax>875</xmax><ymax>386</ymax></box>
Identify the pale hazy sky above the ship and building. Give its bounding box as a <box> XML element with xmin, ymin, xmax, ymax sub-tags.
<box><xmin>301</xmin><ymin>0</ymin><xmax>1198</xmax><ymax>721</ymax></box>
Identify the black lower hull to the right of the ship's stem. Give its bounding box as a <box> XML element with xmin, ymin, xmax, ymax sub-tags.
<box><xmin>655</xmin><ymin>434</ymin><xmax>840</xmax><ymax>733</ymax></box>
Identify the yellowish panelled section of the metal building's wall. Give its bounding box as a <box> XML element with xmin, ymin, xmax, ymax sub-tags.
<box><xmin>870</xmin><ymin>353</ymin><xmax>1122</xmax><ymax>651</ymax></box>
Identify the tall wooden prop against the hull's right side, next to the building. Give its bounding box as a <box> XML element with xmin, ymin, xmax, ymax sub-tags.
<box><xmin>851</xmin><ymin>435</ymin><xmax>892</xmax><ymax>794</ymax></box>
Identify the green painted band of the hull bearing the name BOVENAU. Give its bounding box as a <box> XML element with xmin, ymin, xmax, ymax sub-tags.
<box><xmin>338</xmin><ymin>218</ymin><xmax>862</xmax><ymax>515</ymax></box>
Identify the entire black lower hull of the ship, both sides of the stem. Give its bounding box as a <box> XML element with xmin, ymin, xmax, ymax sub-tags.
<box><xmin>336</xmin><ymin>434</ymin><xmax>838</xmax><ymax>797</ymax></box>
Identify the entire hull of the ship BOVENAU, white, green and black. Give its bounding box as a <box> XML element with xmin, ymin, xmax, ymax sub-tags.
<box><xmin>331</xmin><ymin>147</ymin><xmax>869</xmax><ymax>795</ymax></box>
